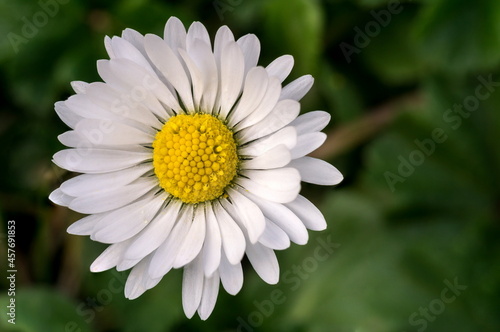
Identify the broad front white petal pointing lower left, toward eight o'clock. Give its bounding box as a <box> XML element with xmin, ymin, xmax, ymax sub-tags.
<box><xmin>90</xmin><ymin>194</ymin><xmax>165</xmax><ymax>243</ymax></box>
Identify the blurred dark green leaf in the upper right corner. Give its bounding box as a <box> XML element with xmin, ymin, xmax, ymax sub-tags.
<box><xmin>415</xmin><ymin>0</ymin><xmax>500</xmax><ymax>73</ymax></box>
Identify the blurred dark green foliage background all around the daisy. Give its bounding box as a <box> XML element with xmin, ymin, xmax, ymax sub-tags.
<box><xmin>0</xmin><ymin>0</ymin><xmax>500</xmax><ymax>332</ymax></box>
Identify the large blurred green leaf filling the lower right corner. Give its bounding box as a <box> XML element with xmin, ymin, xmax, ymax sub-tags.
<box><xmin>268</xmin><ymin>71</ymin><xmax>500</xmax><ymax>331</ymax></box>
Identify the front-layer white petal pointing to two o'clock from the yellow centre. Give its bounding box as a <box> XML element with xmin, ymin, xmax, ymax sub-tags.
<box><xmin>236</xmin><ymin>99</ymin><xmax>300</xmax><ymax>143</ymax></box>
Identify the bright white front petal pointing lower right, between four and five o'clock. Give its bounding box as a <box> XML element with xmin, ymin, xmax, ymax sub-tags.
<box><xmin>240</xmin><ymin>189</ymin><xmax>309</xmax><ymax>244</ymax></box>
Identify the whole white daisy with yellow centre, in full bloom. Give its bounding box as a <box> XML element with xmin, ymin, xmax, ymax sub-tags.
<box><xmin>50</xmin><ymin>17</ymin><xmax>342</xmax><ymax>319</ymax></box>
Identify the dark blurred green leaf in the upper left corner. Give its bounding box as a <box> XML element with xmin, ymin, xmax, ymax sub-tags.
<box><xmin>5</xmin><ymin>1</ymin><xmax>84</xmax><ymax>114</ymax></box>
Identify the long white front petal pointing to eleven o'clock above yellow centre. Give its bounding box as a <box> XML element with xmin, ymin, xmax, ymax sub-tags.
<box><xmin>144</xmin><ymin>34</ymin><xmax>194</xmax><ymax>113</ymax></box>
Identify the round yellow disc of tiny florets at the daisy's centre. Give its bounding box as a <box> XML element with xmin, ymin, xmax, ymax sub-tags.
<box><xmin>153</xmin><ymin>113</ymin><xmax>238</xmax><ymax>204</ymax></box>
